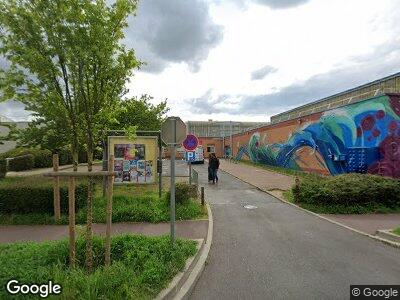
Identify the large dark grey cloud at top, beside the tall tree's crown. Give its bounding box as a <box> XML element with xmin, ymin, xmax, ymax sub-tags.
<box><xmin>125</xmin><ymin>0</ymin><xmax>223</xmax><ymax>73</ymax></box>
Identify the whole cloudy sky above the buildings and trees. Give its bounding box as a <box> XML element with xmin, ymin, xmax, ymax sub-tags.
<box><xmin>0</xmin><ymin>0</ymin><xmax>400</xmax><ymax>122</ymax></box>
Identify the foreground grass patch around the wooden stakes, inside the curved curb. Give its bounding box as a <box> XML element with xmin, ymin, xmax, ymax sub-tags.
<box><xmin>0</xmin><ymin>235</ymin><xmax>196</xmax><ymax>299</ymax></box>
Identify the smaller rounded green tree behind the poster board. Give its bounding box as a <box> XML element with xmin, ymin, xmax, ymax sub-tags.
<box><xmin>113</xmin><ymin>95</ymin><xmax>169</xmax><ymax>130</ymax></box>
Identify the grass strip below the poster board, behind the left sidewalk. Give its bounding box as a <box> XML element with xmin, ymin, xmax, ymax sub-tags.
<box><xmin>0</xmin><ymin>178</ymin><xmax>207</xmax><ymax>225</ymax></box>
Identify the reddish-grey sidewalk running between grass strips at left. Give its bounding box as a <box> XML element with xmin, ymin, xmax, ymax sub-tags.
<box><xmin>0</xmin><ymin>220</ymin><xmax>208</xmax><ymax>243</ymax></box>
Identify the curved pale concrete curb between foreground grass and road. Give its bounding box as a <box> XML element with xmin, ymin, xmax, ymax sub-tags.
<box><xmin>156</xmin><ymin>203</ymin><xmax>214</xmax><ymax>300</ymax></box>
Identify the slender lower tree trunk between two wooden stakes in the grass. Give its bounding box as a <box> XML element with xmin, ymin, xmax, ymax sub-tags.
<box><xmin>86</xmin><ymin>128</ymin><xmax>93</xmax><ymax>273</ymax></box>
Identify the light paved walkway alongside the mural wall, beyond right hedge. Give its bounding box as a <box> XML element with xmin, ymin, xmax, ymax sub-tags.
<box><xmin>220</xmin><ymin>159</ymin><xmax>294</xmax><ymax>191</ymax></box>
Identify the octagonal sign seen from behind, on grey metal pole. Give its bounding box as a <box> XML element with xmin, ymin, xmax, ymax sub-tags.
<box><xmin>161</xmin><ymin>117</ymin><xmax>186</xmax><ymax>244</ymax></box>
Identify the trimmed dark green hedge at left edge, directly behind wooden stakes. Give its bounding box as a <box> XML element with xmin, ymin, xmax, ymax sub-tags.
<box><xmin>0</xmin><ymin>177</ymin><xmax>88</xmax><ymax>214</ymax></box>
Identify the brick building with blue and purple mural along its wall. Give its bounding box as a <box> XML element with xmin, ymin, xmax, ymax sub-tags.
<box><xmin>220</xmin><ymin>73</ymin><xmax>400</xmax><ymax>178</ymax></box>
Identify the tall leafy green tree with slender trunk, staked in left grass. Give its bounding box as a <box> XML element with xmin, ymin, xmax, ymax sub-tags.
<box><xmin>0</xmin><ymin>0</ymin><xmax>140</xmax><ymax>271</ymax></box>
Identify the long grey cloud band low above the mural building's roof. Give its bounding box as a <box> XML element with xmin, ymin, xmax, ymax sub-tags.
<box><xmin>186</xmin><ymin>40</ymin><xmax>400</xmax><ymax>115</ymax></box>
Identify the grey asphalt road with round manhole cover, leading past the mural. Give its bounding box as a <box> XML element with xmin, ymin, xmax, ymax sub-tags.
<box><xmin>191</xmin><ymin>166</ymin><xmax>400</xmax><ymax>299</ymax></box>
